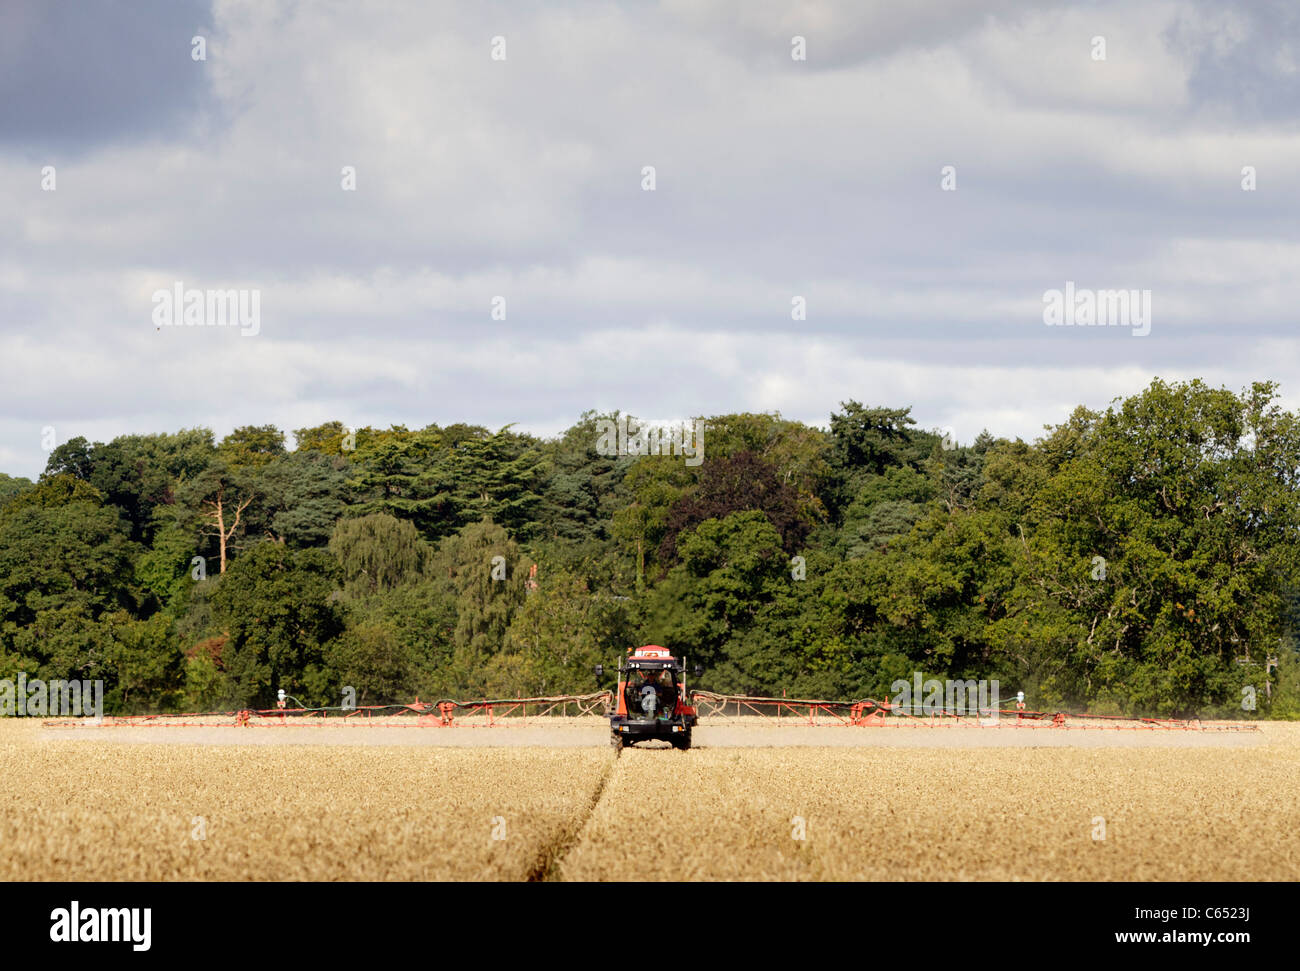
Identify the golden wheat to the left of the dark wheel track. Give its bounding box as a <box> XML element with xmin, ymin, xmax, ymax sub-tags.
<box><xmin>0</xmin><ymin>720</ymin><xmax>612</xmax><ymax>880</ymax></box>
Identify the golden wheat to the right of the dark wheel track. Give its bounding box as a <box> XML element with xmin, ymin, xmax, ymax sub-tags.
<box><xmin>559</xmin><ymin>734</ymin><xmax>1300</xmax><ymax>880</ymax></box>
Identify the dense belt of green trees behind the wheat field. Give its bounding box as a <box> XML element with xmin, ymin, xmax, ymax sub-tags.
<box><xmin>0</xmin><ymin>381</ymin><xmax>1300</xmax><ymax>718</ymax></box>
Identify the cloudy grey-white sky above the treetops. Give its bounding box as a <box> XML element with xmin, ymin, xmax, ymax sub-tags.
<box><xmin>0</xmin><ymin>0</ymin><xmax>1300</xmax><ymax>477</ymax></box>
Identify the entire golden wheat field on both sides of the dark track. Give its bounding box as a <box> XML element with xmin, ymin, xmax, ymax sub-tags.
<box><xmin>0</xmin><ymin>719</ymin><xmax>1300</xmax><ymax>881</ymax></box>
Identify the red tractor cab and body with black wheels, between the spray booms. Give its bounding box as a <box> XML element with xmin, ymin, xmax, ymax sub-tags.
<box><xmin>595</xmin><ymin>643</ymin><xmax>703</xmax><ymax>753</ymax></box>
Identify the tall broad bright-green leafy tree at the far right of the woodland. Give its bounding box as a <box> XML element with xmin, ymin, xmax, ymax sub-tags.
<box><xmin>1008</xmin><ymin>381</ymin><xmax>1300</xmax><ymax>712</ymax></box>
